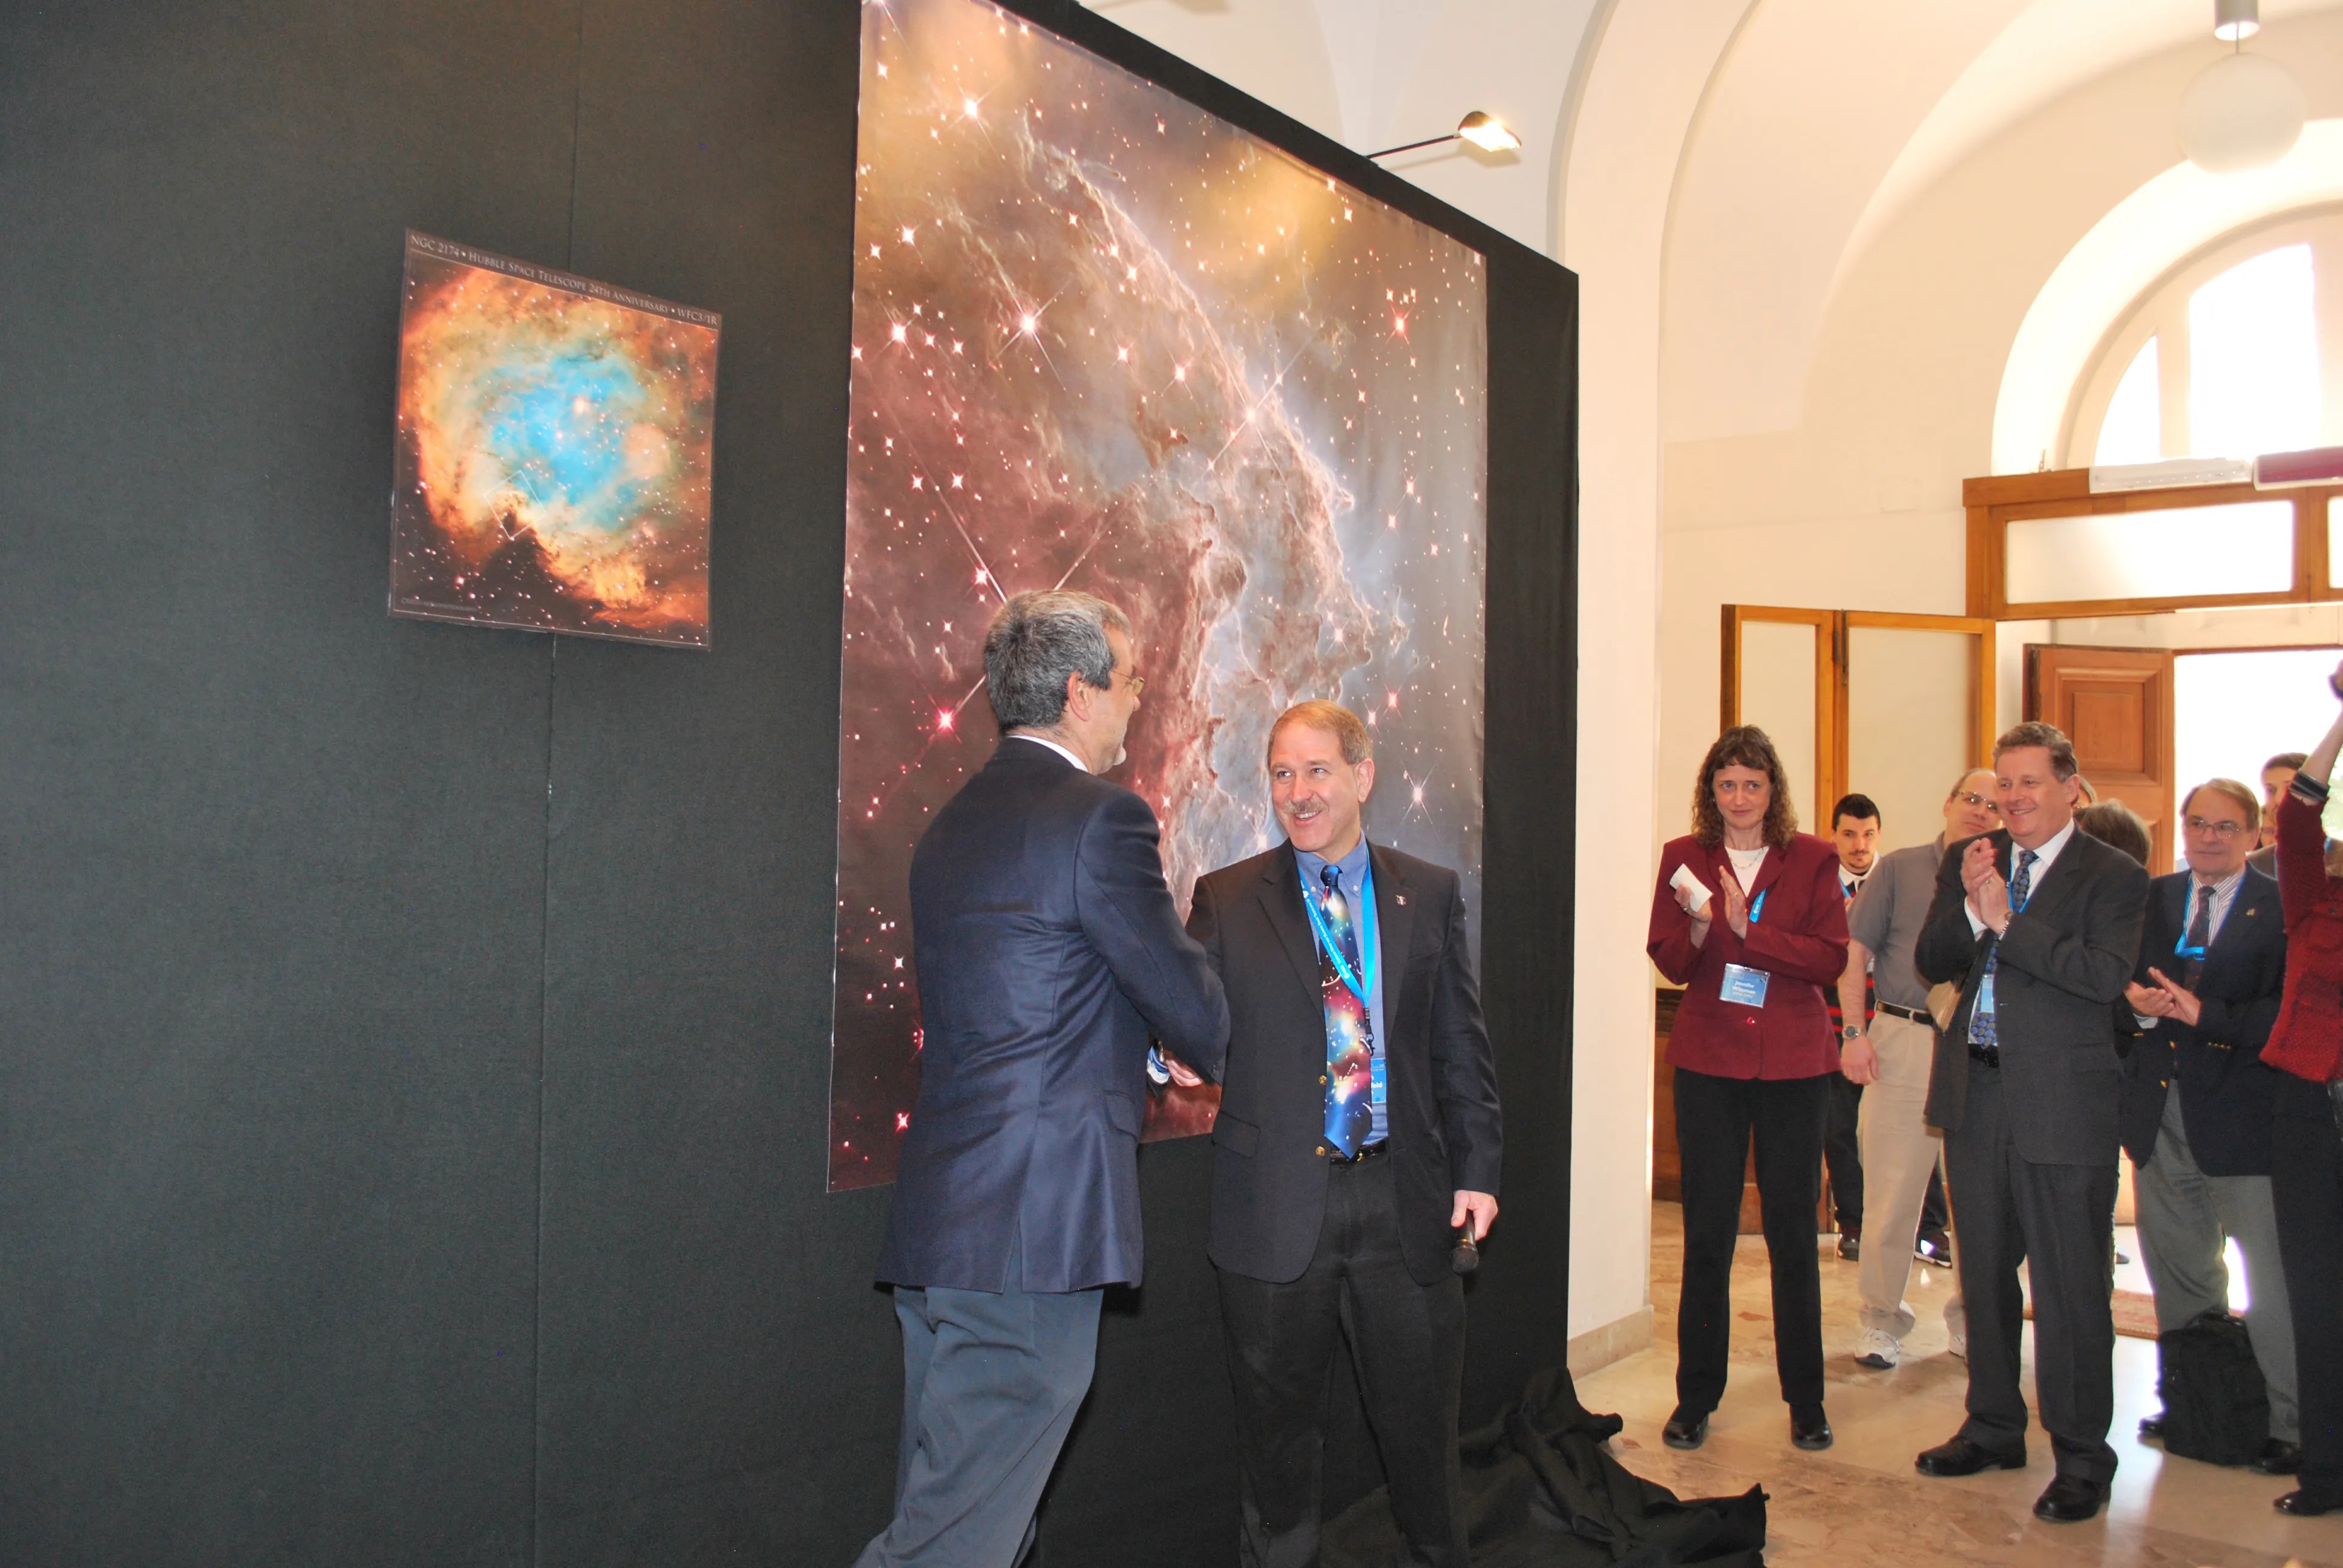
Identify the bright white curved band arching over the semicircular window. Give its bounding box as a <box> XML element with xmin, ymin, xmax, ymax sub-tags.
<box><xmin>1994</xmin><ymin>120</ymin><xmax>2343</xmax><ymax>474</ymax></box>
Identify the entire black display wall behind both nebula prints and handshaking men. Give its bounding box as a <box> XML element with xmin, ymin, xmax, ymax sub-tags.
<box><xmin>0</xmin><ymin>0</ymin><xmax>1577</xmax><ymax>1568</ymax></box>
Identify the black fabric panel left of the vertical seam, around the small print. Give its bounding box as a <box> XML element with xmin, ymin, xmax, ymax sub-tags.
<box><xmin>0</xmin><ymin>0</ymin><xmax>577</xmax><ymax>1563</ymax></box>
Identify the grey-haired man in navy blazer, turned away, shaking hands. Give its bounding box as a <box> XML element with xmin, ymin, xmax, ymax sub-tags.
<box><xmin>857</xmin><ymin>593</ymin><xmax>1228</xmax><ymax>1568</ymax></box>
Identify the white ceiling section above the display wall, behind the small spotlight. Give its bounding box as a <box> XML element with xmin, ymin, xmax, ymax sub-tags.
<box><xmin>1087</xmin><ymin>0</ymin><xmax>1598</xmax><ymax>251</ymax></box>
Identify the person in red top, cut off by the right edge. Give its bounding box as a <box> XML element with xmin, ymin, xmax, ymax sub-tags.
<box><xmin>2261</xmin><ymin>665</ymin><xmax>2343</xmax><ymax>1514</ymax></box>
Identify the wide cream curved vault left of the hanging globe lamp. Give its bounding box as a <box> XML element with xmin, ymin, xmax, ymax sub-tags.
<box><xmin>1663</xmin><ymin>0</ymin><xmax>2343</xmax><ymax>440</ymax></box>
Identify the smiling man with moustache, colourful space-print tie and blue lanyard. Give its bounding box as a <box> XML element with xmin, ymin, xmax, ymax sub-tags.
<box><xmin>1188</xmin><ymin>703</ymin><xmax>1502</xmax><ymax>1568</ymax></box>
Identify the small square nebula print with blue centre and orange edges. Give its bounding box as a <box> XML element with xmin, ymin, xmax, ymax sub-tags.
<box><xmin>392</xmin><ymin>232</ymin><xmax>722</xmax><ymax>647</ymax></box>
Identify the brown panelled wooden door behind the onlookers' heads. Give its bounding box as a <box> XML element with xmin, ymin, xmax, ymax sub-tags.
<box><xmin>2027</xmin><ymin>642</ymin><xmax>2179</xmax><ymax>874</ymax></box>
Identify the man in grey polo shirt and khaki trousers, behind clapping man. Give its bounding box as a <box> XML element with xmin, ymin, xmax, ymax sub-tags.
<box><xmin>1840</xmin><ymin>769</ymin><xmax>2001</xmax><ymax>1371</ymax></box>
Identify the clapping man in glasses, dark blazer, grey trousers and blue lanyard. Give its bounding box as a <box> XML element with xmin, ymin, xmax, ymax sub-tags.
<box><xmin>2118</xmin><ymin>778</ymin><xmax>2301</xmax><ymax>1474</ymax></box>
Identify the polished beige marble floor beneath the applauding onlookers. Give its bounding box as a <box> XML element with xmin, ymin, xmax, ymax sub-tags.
<box><xmin>1579</xmin><ymin>1203</ymin><xmax>2343</xmax><ymax>1568</ymax></box>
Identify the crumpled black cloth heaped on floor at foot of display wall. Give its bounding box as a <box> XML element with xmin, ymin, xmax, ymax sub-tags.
<box><xmin>1322</xmin><ymin>1367</ymin><xmax>1765</xmax><ymax>1568</ymax></box>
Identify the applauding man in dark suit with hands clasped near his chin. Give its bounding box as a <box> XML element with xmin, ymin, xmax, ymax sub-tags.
<box><xmin>1914</xmin><ymin>722</ymin><xmax>2149</xmax><ymax>1523</ymax></box>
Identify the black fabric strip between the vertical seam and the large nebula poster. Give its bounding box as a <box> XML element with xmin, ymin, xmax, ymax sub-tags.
<box><xmin>522</xmin><ymin>0</ymin><xmax>900</xmax><ymax>1563</ymax></box>
